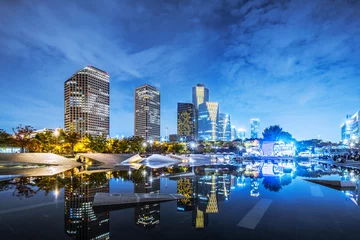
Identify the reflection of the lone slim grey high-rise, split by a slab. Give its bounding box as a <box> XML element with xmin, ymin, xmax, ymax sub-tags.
<box><xmin>134</xmin><ymin>170</ymin><xmax>160</xmax><ymax>230</ymax></box>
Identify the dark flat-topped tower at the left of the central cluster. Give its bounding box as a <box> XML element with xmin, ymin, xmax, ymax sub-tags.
<box><xmin>177</xmin><ymin>103</ymin><xmax>197</xmax><ymax>141</ymax></box>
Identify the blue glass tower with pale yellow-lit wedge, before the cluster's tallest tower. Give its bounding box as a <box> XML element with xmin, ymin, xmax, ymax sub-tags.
<box><xmin>198</xmin><ymin>102</ymin><xmax>219</xmax><ymax>141</ymax></box>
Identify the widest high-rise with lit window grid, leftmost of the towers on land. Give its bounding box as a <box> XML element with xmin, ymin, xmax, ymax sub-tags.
<box><xmin>64</xmin><ymin>65</ymin><xmax>110</xmax><ymax>137</ymax></box>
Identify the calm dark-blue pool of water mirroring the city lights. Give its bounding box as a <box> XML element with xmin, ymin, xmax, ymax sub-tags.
<box><xmin>0</xmin><ymin>163</ymin><xmax>360</xmax><ymax>239</ymax></box>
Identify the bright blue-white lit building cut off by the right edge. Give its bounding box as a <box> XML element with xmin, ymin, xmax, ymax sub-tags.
<box><xmin>341</xmin><ymin>111</ymin><xmax>360</xmax><ymax>141</ymax></box>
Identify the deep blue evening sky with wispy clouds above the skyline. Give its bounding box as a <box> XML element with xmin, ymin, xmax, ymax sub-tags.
<box><xmin>0</xmin><ymin>0</ymin><xmax>360</xmax><ymax>141</ymax></box>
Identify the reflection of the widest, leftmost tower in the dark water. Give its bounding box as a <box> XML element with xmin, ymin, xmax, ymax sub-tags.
<box><xmin>64</xmin><ymin>173</ymin><xmax>110</xmax><ymax>240</ymax></box>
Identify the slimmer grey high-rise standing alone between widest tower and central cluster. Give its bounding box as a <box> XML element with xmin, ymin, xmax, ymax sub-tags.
<box><xmin>134</xmin><ymin>84</ymin><xmax>160</xmax><ymax>141</ymax></box>
